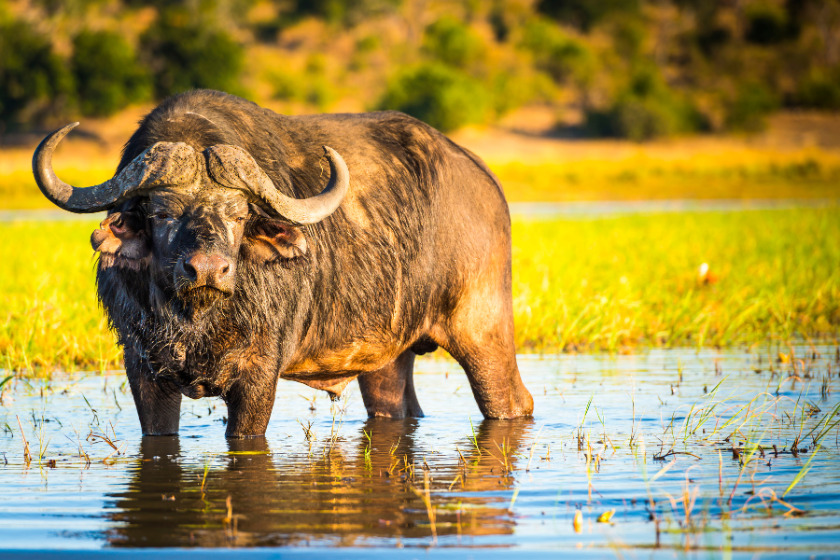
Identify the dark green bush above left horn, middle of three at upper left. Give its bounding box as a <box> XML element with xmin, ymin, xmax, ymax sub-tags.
<box><xmin>71</xmin><ymin>31</ymin><xmax>151</xmax><ymax>116</ymax></box>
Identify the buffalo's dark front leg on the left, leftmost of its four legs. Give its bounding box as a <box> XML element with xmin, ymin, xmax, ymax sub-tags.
<box><xmin>125</xmin><ymin>348</ymin><xmax>181</xmax><ymax>436</ymax></box>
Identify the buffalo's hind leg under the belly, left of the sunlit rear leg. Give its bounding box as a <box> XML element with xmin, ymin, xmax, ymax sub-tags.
<box><xmin>358</xmin><ymin>350</ymin><xmax>423</xmax><ymax>418</ymax></box>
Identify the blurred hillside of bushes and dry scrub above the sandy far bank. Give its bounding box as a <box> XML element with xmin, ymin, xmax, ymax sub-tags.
<box><xmin>0</xmin><ymin>0</ymin><xmax>840</xmax><ymax>136</ymax></box>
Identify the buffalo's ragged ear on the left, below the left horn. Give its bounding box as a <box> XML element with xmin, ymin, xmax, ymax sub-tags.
<box><xmin>90</xmin><ymin>212</ymin><xmax>152</xmax><ymax>269</ymax></box>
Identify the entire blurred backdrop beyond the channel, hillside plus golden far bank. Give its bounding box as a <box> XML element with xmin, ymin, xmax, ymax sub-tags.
<box><xmin>0</xmin><ymin>0</ymin><xmax>840</xmax><ymax>208</ymax></box>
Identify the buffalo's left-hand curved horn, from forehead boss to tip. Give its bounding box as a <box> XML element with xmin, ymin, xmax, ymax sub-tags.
<box><xmin>32</xmin><ymin>123</ymin><xmax>205</xmax><ymax>213</ymax></box>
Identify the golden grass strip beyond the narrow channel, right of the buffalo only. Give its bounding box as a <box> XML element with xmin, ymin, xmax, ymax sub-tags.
<box><xmin>491</xmin><ymin>147</ymin><xmax>840</xmax><ymax>202</ymax></box>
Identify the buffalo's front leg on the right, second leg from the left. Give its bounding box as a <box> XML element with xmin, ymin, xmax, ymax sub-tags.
<box><xmin>224</xmin><ymin>376</ymin><xmax>277</xmax><ymax>438</ymax></box>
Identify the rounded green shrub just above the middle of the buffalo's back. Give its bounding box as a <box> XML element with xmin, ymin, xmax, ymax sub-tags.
<box><xmin>377</xmin><ymin>63</ymin><xmax>491</xmax><ymax>132</ymax></box>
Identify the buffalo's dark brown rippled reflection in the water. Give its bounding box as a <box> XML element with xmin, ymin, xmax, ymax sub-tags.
<box><xmin>106</xmin><ymin>418</ymin><xmax>531</xmax><ymax>547</ymax></box>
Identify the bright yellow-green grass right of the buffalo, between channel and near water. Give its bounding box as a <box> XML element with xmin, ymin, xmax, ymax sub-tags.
<box><xmin>513</xmin><ymin>206</ymin><xmax>840</xmax><ymax>351</ymax></box>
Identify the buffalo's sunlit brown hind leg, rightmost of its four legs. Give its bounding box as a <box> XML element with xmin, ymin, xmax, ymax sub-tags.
<box><xmin>441</xmin><ymin>273</ymin><xmax>534</xmax><ymax>418</ymax></box>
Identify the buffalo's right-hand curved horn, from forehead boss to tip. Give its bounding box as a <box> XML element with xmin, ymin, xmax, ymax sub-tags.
<box><xmin>206</xmin><ymin>144</ymin><xmax>350</xmax><ymax>225</ymax></box>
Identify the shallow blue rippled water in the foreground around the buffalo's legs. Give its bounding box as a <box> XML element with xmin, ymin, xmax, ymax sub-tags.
<box><xmin>0</xmin><ymin>347</ymin><xmax>840</xmax><ymax>558</ymax></box>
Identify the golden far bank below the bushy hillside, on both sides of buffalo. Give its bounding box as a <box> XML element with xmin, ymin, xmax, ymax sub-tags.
<box><xmin>0</xmin><ymin>140</ymin><xmax>840</xmax><ymax>209</ymax></box>
